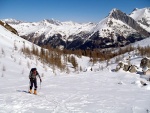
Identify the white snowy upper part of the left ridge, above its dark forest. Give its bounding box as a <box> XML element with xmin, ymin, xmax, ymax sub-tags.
<box><xmin>3</xmin><ymin>19</ymin><xmax>95</xmax><ymax>41</ymax></box>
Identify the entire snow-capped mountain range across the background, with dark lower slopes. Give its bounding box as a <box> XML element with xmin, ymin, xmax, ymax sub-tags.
<box><xmin>3</xmin><ymin>8</ymin><xmax>150</xmax><ymax>49</ymax></box>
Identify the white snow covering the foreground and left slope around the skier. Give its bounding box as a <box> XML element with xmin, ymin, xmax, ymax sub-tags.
<box><xmin>0</xmin><ymin>26</ymin><xmax>150</xmax><ymax>113</ymax></box>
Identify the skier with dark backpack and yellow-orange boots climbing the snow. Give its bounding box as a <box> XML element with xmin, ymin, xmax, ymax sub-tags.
<box><xmin>29</xmin><ymin>68</ymin><xmax>42</xmax><ymax>95</ymax></box>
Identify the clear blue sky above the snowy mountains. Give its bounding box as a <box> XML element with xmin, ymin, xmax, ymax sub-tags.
<box><xmin>0</xmin><ymin>0</ymin><xmax>150</xmax><ymax>23</ymax></box>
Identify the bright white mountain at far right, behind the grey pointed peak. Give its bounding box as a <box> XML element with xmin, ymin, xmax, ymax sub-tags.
<box><xmin>130</xmin><ymin>8</ymin><xmax>150</xmax><ymax>32</ymax></box>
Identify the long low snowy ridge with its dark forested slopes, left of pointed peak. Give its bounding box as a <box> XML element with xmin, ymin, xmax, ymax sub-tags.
<box><xmin>3</xmin><ymin>19</ymin><xmax>95</xmax><ymax>48</ymax></box>
